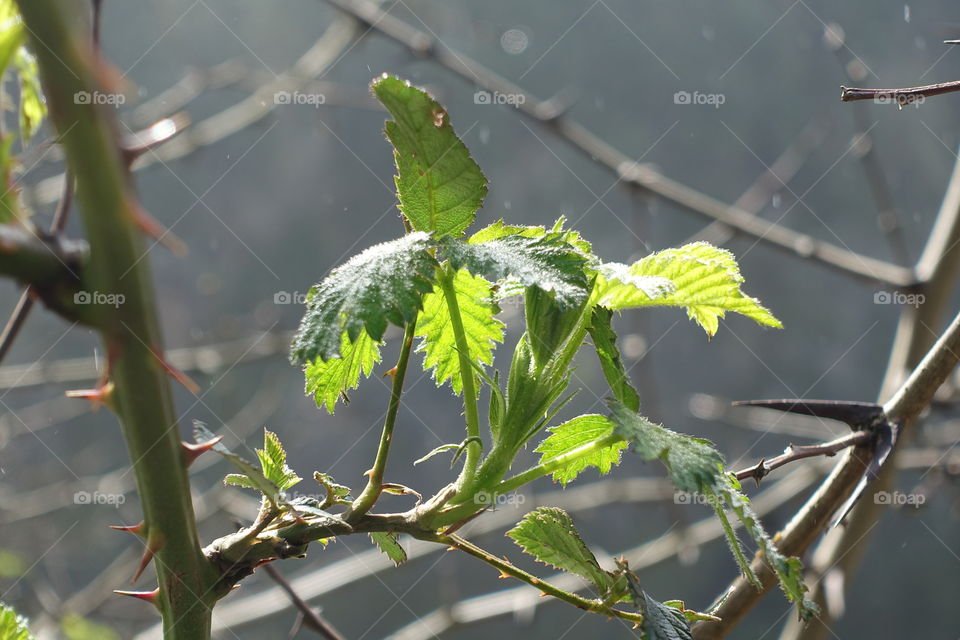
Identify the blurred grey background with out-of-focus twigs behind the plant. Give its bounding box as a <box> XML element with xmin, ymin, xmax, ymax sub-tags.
<box><xmin>0</xmin><ymin>0</ymin><xmax>960</xmax><ymax>640</ymax></box>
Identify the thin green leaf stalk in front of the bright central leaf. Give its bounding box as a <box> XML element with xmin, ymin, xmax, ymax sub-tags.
<box><xmin>438</xmin><ymin>265</ymin><xmax>483</xmax><ymax>491</ymax></box>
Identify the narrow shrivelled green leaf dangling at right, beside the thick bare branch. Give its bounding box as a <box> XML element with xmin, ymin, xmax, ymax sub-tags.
<box><xmin>716</xmin><ymin>474</ymin><xmax>819</xmax><ymax>620</ymax></box>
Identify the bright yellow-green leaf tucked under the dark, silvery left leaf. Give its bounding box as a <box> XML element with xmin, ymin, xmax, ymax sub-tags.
<box><xmin>303</xmin><ymin>330</ymin><xmax>383</xmax><ymax>413</ymax></box>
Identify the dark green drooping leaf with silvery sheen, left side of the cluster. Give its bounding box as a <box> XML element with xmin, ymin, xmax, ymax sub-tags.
<box><xmin>290</xmin><ymin>232</ymin><xmax>435</xmax><ymax>364</ymax></box>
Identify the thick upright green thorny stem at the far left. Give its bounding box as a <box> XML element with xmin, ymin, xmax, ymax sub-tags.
<box><xmin>17</xmin><ymin>0</ymin><xmax>222</xmax><ymax>640</ymax></box>
